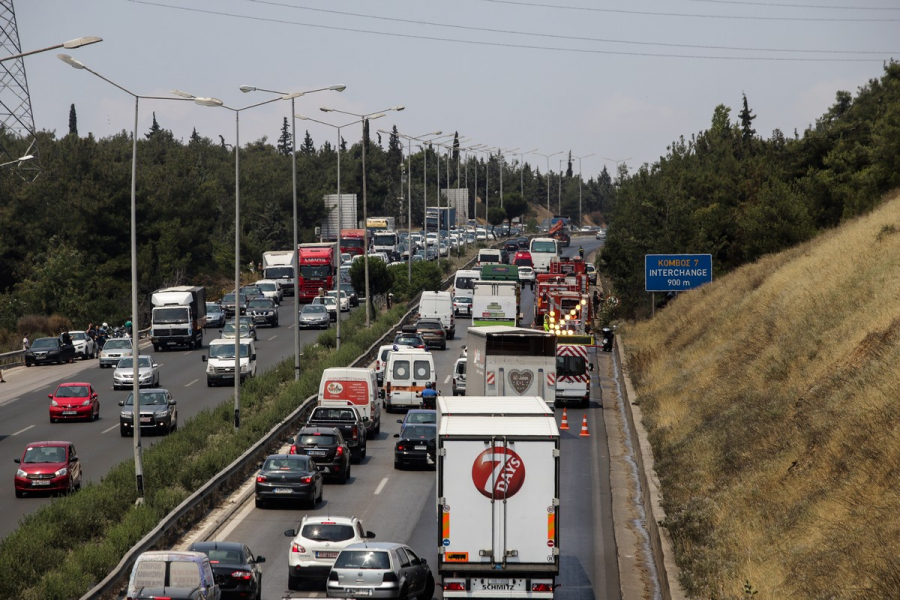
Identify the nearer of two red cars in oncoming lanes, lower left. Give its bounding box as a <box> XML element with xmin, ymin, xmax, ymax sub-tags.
<box><xmin>14</xmin><ymin>442</ymin><xmax>81</xmax><ymax>498</ymax></box>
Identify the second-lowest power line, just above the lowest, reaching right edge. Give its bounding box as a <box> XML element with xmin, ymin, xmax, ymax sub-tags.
<box><xmin>237</xmin><ymin>0</ymin><xmax>900</xmax><ymax>56</ymax></box>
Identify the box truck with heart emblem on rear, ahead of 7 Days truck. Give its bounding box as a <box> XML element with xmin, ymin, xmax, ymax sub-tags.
<box><xmin>466</xmin><ymin>325</ymin><xmax>556</xmax><ymax>406</ymax></box>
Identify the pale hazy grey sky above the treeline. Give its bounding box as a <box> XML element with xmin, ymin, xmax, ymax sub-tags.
<box><xmin>15</xmin><ymin>0</ymin><xmax>900</xmax><ymax>178</ymax></box>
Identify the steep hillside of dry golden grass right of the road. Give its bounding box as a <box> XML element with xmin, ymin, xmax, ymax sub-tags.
<box><xmin>622</xmin><ymin>194</ymin><xmax>900</xmax><ymax>600</ymax></box>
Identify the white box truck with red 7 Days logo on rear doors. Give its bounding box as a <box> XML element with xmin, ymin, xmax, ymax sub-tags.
<box><xmin>436</xmin><ymin>404</ymin><xmax>560</xmax><ymax>599</ymax></box>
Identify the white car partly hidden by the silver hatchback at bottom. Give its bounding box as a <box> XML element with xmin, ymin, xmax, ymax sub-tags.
<box><xmin>284</xmin><ymin>515</ymin><xmax>375</xmax><ymax>590</ymax></box>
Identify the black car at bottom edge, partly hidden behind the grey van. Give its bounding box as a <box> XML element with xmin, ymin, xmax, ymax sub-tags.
<box><xmin>188</xmin><ymin>542</ymin><xmax>266</xmax><ymax>600</ymax></box>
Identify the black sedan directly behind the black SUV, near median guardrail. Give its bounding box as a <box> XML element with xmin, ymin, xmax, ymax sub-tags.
<box><xmin>255</xmin><ymin>454</ymin><xmax>325</xmax><ymax>508</ymax></box>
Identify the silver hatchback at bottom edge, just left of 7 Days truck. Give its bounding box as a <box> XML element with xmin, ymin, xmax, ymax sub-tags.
<box><xmin>326</xmin><ymin>542</ymin><xmax>434</xmax><ymax>598</ymax></box>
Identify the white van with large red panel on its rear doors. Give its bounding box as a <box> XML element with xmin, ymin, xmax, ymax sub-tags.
<box><xmin>319</xmin><ymin>367</ymin><xmax>381</xmax><ymax>438</ymax></box>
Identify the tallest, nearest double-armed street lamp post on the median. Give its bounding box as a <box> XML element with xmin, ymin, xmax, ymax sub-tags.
<box><xmin>59</xmin><ymin>54</ymin><xmax>222</xmax><ymax>504</ymax></box>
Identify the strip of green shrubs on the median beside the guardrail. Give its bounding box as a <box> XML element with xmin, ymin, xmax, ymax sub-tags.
<box><xmin>0</xmin><ymin>305</ymin><xmax>406</xmax><ymax>600</ymax></box>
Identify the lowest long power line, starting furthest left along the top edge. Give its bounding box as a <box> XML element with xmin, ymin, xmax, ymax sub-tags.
<box><xmin>128</xmin><ymin>0</ymin><xmax>883</xmax><ymax>62</ymax></box>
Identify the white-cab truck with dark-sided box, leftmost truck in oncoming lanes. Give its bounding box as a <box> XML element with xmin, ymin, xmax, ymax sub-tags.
<box><xmin>150</xmin><ymin>285</ymin><xmax>206</xmax><ymax>352</ymax></box>
